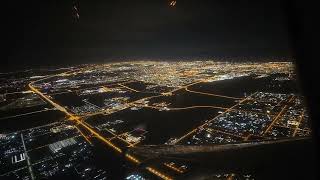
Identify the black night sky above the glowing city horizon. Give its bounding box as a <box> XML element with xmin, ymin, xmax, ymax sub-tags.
<box><xmin>6</xmin><ymin>0</ymin><xmax>291</xmax><ymax>70</ymax></box>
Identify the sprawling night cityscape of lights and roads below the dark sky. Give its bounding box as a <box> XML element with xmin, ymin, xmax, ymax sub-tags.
<box><xmin>0</xmin><ymin>61</ymin><xmax>312</xmax><ymax>180</ymax></box>
